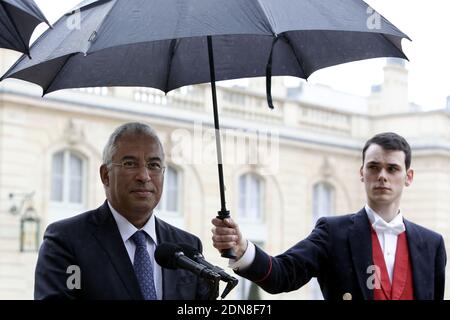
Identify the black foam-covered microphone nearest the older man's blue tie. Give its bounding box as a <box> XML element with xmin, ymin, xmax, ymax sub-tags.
<box><xmin>155</xmin><ymin>242</ymin><xmax>220</xmax><ymax>281</ymax></box>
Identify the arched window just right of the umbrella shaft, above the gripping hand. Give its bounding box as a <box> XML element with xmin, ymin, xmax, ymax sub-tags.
<box><xmin>238</xmin><ymin>173</ymin><xmax>264</xmax><ymax>222</ymax></box>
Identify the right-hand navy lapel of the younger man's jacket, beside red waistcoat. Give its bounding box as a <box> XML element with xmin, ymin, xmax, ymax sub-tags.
<box><xmin>403</xmin><ymin>219</ymin><xmax>434</xmax><ymax>300</ymax></box>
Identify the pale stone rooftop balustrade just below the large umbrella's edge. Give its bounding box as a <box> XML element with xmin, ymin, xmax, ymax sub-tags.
<box><xmin>35</xmin><ymin>85</ymin><xmax>358</xmax><ymax>136</ymax></box>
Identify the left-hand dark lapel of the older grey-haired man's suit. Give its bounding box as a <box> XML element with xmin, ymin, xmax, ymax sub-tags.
<box><xmin>93</xmin><ymin>201</ymin><xmax>142</xmax><ymax>300</ymax></box>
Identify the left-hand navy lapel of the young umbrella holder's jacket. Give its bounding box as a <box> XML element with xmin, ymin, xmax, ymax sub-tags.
<box><xmin>348</xmin><ymin>209</ymin><xmax>373</xmax><ymax>300</ymax></box>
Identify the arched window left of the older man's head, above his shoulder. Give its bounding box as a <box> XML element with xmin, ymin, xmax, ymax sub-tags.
<box><xmin>48</xmin><ymin>150</ymin><xmax>87</xmax><ymax>222</ymax></box>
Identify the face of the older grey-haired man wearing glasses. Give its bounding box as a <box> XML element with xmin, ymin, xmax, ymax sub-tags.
<box><xmin>100</xmin><ymin>135</ymin><xmax>164</xmax><ymax>218</ymax></box>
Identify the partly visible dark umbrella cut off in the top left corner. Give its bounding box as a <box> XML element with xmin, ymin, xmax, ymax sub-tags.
<box><xmin>0</xmin><ymin>0</ymin><xmax>50</xmax><ymax>56</ymax></box>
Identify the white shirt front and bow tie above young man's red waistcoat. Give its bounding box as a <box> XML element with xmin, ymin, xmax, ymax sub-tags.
<box><xmin>365</xmin><ymin>204</ymin><xmax>405</xmax><ymax>283</ymax></box>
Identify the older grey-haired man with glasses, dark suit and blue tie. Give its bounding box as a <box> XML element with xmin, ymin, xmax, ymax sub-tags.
<box><xmin>35</xmin><ymin>123</ymin><xmax>210</xmax><ymax>300</ymax></box>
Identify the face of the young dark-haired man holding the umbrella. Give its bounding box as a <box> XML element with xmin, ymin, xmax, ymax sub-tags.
<box><xmin>360</xmin><ymin>144</ymin><xmax>414</xmax><ymax>205</ymax></box>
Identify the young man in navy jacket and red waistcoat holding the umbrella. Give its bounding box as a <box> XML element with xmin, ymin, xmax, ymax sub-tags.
<box><xmin>212</xmin><ymin>133</ymin><xmax>446</xmax><ymax>300</ymax></box>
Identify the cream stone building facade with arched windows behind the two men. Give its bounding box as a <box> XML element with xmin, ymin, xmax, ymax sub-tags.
<box><xmin>0</xmin><ymin>52</ymin><xmax>450</xmax><ymax>299</ymax></box>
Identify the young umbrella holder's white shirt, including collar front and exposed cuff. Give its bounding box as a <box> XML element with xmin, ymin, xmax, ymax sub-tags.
<box><xmin>232</xmin><ymin>205</ymin><xmax>405</xmax><ymax>283</ymax></box>
